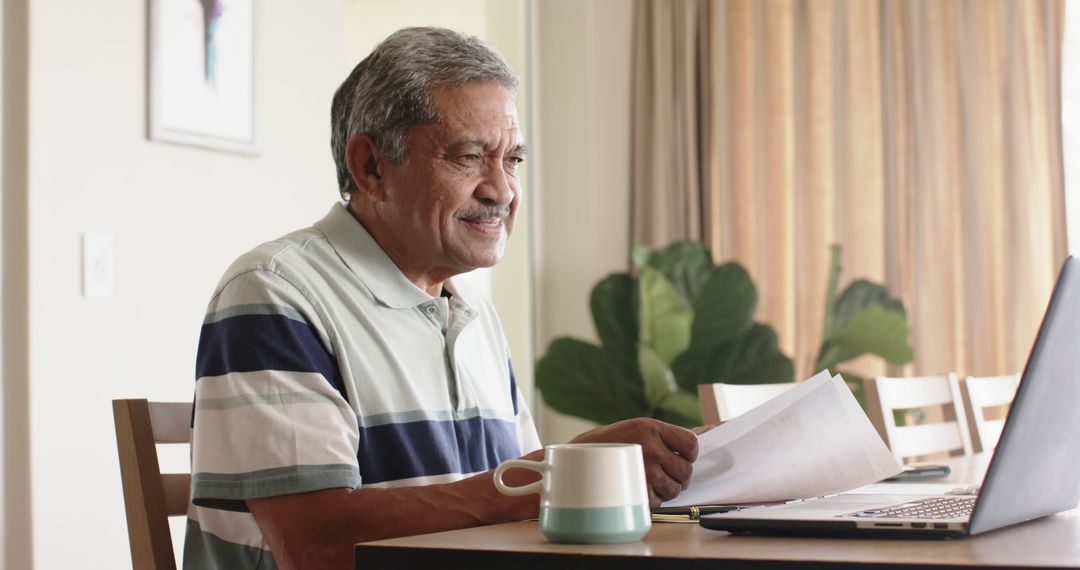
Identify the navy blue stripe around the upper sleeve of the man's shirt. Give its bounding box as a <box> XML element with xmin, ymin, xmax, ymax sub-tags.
<box><xmin>195</xmin><ymin>314</ymin><xmax>348</xmax><ymax>399</ymax></box>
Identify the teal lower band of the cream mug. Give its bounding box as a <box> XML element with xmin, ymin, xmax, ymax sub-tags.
<box><xmin>540</xmin><ymin>504</ymin><xmax>652</xmax><ymax>544</ymax></box>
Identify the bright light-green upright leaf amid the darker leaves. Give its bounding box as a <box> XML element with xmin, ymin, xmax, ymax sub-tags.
<box><xmin>637</xmin><ymin>267</ymin><xmax>693</xmax><ymax>364</ymax></box>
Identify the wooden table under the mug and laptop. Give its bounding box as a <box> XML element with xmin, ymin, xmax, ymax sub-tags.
<box><xmin>356</xmin><ymin>458</ymin><xmax>1080</xmax><ymax>570</ymax></box>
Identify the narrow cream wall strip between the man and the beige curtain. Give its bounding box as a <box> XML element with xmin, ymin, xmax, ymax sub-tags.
<box><xmin>536</xmin><ymin>0</ymin><xmax>634</xmax><ymax>444</ymax></box>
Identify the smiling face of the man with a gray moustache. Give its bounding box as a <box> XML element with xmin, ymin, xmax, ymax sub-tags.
<box><xmin>377</xmin><ymin>82</ymin><xmax>525</xmax><ymax>279</ymax></box>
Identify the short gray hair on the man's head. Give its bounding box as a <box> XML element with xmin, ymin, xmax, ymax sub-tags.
<box><xmin>330</xmin><ymin>28</ymin><xmax>517</xmax><ymax>201</ymax></box>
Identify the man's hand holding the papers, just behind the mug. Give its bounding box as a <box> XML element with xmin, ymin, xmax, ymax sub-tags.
<box><xmin>570</xmin><ymin>418</ymin><xmax>698</xmax><ymax>507</ymax></box>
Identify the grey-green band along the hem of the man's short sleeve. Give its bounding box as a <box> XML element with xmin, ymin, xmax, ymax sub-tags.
<box><xmin>191</xmin><ymin>463</ymin><xmax>360</xmax><ymax>503</ymax></box>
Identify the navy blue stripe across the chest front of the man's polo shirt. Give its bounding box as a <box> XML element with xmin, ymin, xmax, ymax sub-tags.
<box><xmin>356</xmin><ymin>417</ymin><xmax>522</xmax><ymax>484</ymax></box>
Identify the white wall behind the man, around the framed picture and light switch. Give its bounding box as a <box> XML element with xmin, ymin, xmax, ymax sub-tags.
<box><xmin>21</xmin><ymin>0</ymin><xmax>350</xmax><ymax>569</ymax></box>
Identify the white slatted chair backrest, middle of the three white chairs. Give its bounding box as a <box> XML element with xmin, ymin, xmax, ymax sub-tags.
<box><xmin>865</xmin><ymin>372</ymin><xmax>972</xmax><ymax>461</ymax></box>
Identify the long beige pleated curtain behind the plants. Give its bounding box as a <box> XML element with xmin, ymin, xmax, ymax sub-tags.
<box><xmin>633</xmin><ymin>0</ymin><xmax>1066</xmax><ymax>382</ymax></box>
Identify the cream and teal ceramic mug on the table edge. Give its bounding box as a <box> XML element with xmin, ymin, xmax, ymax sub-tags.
<box><xmin>495</xmin><ymin>444</ymin><xmax>652</xmax><ymax>543</ymax></box>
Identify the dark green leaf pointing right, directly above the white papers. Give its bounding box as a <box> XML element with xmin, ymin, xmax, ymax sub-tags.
<box><xmin>672</xmin><ymin>323</ymin><xmax>795</xmax><ymax>393</ymax></box>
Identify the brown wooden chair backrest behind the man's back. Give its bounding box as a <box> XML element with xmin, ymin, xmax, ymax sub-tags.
<box><xmin>112</xmin><ymin>399</ymin><xmax>191</xmax><ymax>570</ymax></box>
